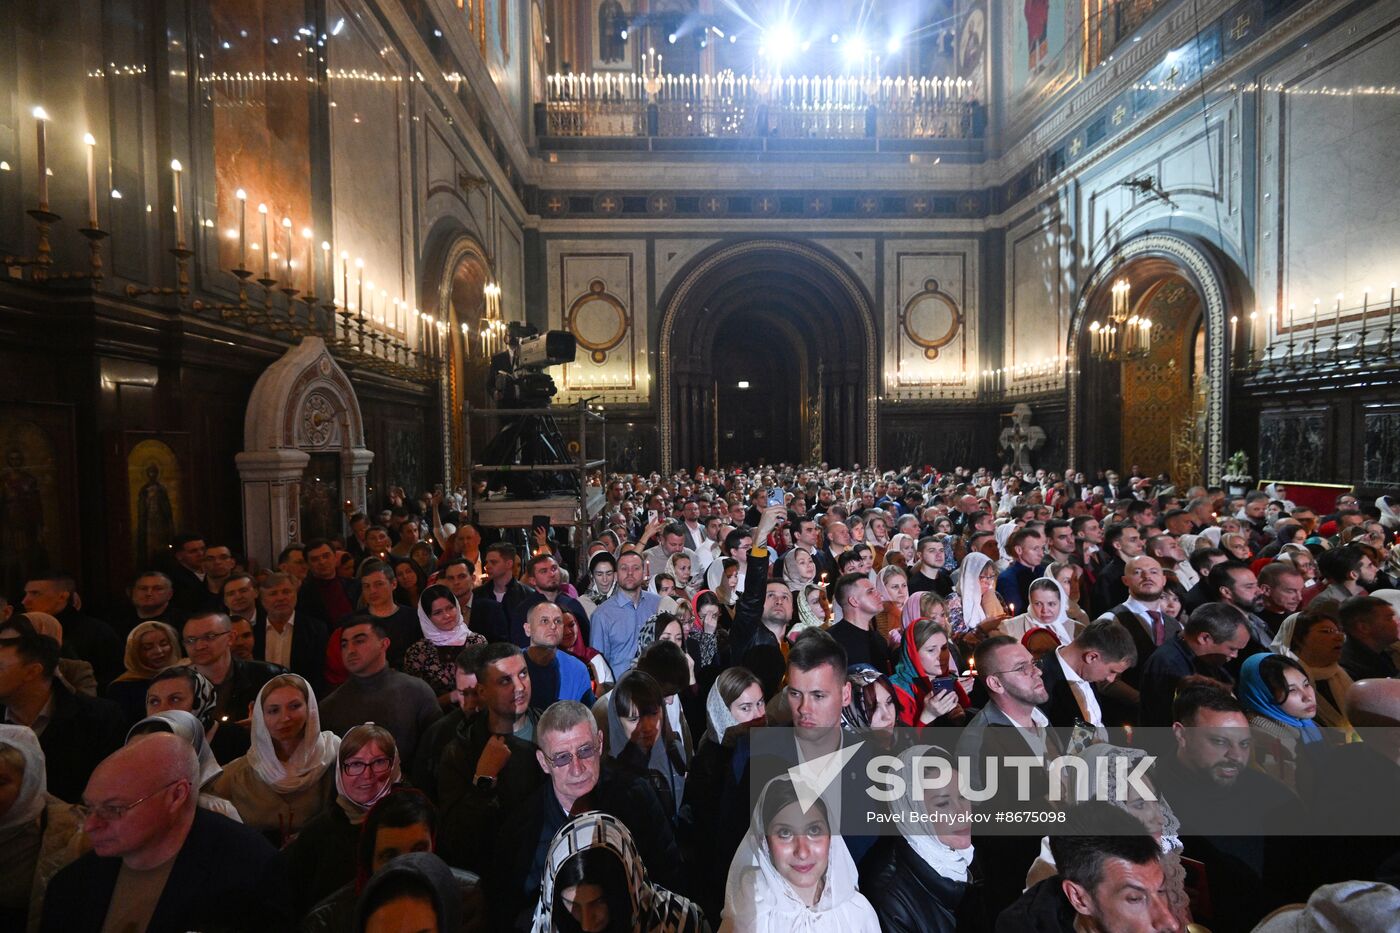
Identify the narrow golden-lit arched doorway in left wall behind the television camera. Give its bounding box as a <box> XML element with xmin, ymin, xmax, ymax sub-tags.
<box><xmin>434</xmin><ymin>237</ymin><xmax>491</xmax><ymax>485</ymax></box>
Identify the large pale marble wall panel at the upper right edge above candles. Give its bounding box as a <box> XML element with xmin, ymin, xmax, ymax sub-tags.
<box><xmin>1259</xmin><ymin>3</ymin><xmax>1400</xmax><ymax>345</ymax></box>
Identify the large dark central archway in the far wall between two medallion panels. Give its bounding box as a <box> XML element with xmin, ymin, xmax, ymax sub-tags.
<box><xmin>659</xmin><ymin>240</ymin><xmax>879</xmax><ymax>472</ymax></box>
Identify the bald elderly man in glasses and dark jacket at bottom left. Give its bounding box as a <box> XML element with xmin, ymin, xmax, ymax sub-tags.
<box><xmin>41</xmin><ymin>734</ymin><xmax>276</xmax><ymax>933</ymax></box>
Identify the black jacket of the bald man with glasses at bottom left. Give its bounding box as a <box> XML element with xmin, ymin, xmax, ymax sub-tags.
<box><xmin>39</xmin><ymin>810</ymin><xmax>281</xmax><ymax>933</ymax></box>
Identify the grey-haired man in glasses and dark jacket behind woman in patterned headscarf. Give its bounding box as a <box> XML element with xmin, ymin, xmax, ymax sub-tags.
<box><xmin>486</xmin><ymin>700</ymin><xmax>683</xmax><ymax>930</ymax></box>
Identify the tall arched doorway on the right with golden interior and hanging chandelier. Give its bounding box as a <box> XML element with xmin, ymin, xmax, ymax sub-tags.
<box><xmin>1070</xmin><ymin>234</ymin><xmax>1231</xmax><ymax>485</ymax></box>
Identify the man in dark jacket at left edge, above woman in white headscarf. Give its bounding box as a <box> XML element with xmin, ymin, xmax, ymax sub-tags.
<box><xmin>0</xmin><ymin>612</ymin><xmax>126</xmax><ymax>803</ymax></box>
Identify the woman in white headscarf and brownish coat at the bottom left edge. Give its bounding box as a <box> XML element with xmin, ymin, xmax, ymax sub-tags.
<box><xmin>0</xmin><ymin>723</ymin><xmax>90</xmax><ymax>930</ymax></box>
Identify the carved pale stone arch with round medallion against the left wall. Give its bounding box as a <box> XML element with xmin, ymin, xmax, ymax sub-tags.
<box><xmin>234</xmin><ymin>336</ymin><xmax>374</xmax><ymax>566</ymax></box>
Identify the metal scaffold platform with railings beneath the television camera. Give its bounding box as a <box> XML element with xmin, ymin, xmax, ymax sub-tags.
<box><xmin>463</xmin><ymin>401</ymin><xmax>608</xmax><ymax>542</ymax></box>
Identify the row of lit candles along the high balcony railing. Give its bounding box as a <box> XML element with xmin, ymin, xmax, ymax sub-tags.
<box><xmin>546</xmin><ymin>70</ymin><xmax>970</xmax><ymax>106</ymax></box>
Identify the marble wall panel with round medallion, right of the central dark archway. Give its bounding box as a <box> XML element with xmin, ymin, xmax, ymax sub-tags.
<box><xmin>882</xmin><ymin>240</ymin><xmax>980</xmax><ymax>399</ymax></box>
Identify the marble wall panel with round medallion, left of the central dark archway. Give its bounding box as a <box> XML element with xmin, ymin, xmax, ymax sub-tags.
<box><xmin>545</xmin><ymin>240</ymin><xmax>651</xmax><ymax>402</ymax></box>
